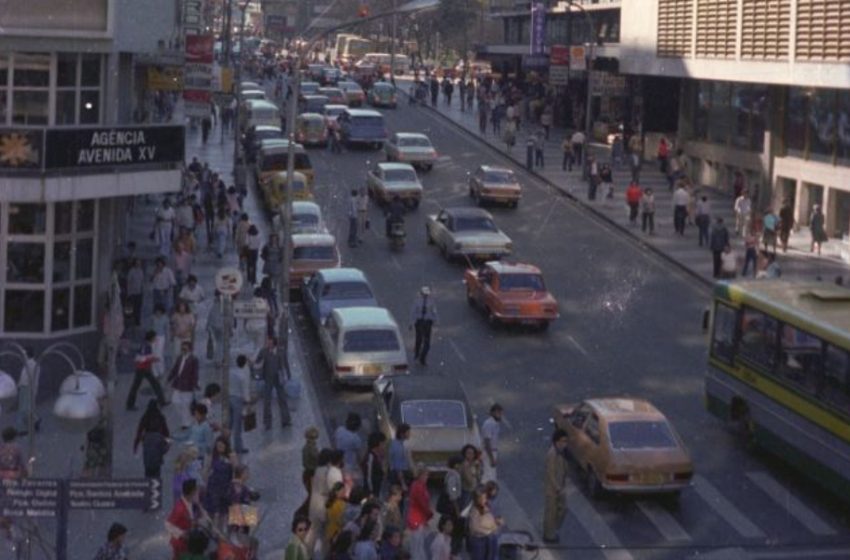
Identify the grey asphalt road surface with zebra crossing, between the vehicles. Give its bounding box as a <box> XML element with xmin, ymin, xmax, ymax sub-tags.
<box><xmin>284</xmin><ymin>97</ymin><xmax>850</xmax><ymax>558</ymax></box>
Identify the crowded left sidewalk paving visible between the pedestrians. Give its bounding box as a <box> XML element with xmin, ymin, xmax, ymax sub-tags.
<box><xmin>17</xmin><ymin>120</ymin><xmax>327</xmax><ymax>560</ymax></box>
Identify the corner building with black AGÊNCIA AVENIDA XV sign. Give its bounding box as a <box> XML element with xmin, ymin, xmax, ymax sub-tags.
<box><xmin>0</xmin><ymin>0</ymin><xmax>185</xmax><ymax>355</ymax></box>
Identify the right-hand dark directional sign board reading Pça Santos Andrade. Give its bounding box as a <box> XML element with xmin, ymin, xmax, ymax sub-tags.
<box><xmin>68</xmin><ymin>478</ymin><xmax>162</xmax><ymax>511</ymax></box>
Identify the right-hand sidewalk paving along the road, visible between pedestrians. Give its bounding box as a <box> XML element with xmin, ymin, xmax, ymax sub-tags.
<box><xmin>398</xmin><ymin>77</ymin><xmax>850</xmax><ymax>282</ymax></box>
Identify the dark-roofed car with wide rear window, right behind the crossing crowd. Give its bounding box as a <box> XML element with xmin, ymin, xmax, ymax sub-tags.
<box><xmin>372</xmin><ymin>375</ymin><xmax>481</xmax><ymax>472</ymax></box>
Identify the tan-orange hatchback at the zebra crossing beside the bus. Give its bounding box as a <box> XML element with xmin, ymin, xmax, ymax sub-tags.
<box><xmin>553</xmin><ymin>398</ymin><xmax>694</xmax><ymax>497</ymax></box>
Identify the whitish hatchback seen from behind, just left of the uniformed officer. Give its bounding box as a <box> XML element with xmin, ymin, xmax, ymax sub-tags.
<box><xmin>319</xmin><ymin>307</ymin><xmax>409</xmax><ymax>386</ymax></box>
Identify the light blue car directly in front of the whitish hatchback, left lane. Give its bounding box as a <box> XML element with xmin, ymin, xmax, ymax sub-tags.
<box><xmin>301</xmin><ymin>268</ymin><xmax>378</xmax><ymax>325</ymax></box>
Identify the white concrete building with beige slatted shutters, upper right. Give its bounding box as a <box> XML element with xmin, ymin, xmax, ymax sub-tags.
<box><xmin>620</xmin><ymin>0</ymin><xmax>850</xmax><ymax>237</ymax></box>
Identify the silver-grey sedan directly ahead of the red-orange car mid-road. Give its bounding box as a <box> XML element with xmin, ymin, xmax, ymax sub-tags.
<box><xmin>425</xmin><ymin>208</ymin><xmax>513</xmax><ymax>260</ymax></box>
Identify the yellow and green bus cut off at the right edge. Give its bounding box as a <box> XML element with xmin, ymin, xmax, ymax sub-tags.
<box><xmin>705</xmin><ymin>280</ymin><xmax>850</xmax><ymax>501</ymax></box>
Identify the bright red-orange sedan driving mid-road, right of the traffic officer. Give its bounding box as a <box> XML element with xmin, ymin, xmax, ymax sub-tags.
<box><xmin>463</xmin><ymin>261</ymin><xmax>558</xmax><ymax>329</ymax></box>
